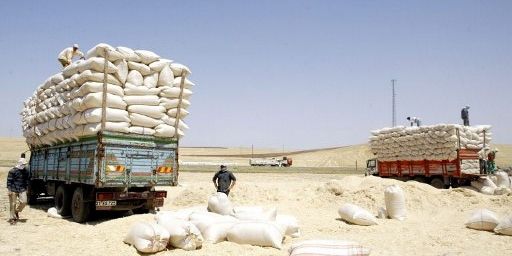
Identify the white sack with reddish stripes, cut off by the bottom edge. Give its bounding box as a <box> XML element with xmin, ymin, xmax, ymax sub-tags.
<box><xmin>288</xmin><ymin>240</ymin><xmax>370</xmax><ymax>256</ymax></box>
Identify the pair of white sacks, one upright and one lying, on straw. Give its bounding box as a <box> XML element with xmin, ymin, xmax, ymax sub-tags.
<box><xmin>338</xmin><ymin>185</ymin><xmax>407</xmax><ymax>226</ymax></box>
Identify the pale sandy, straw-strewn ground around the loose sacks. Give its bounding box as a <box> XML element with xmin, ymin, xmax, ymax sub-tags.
<box><xmin>0</xmin><ymin>168</ymin><xmax>512</xmax><ymax>256</ymax></box>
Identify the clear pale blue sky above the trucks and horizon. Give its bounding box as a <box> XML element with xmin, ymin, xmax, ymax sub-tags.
<box><xmin>0</xmin><ymin>0</ymin><xmax>512</xmax><ymax>149</ymax></box>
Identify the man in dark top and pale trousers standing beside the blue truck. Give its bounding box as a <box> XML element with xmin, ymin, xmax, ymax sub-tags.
<box><xmin>7</xmin><ymin>158</ymin><xmax>29</xmax><ymax>225</ymax></box>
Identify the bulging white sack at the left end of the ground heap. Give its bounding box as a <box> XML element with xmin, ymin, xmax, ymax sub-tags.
<box><xmin>124</xmin><ymin>222</ymin><xmax>170</xmax><ymax>253</ymax></box>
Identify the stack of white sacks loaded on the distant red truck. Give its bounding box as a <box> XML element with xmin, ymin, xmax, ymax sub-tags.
<box><xmin>369</xmin><ymin>124</ymin><xmax>492</xmax><ymax>171</ymax></box>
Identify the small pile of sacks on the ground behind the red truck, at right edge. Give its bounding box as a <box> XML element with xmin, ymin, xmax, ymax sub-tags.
<box><xmin>471</xmin><ymin>171</ymin><xmax>512</xmax><ymax>195</ymax></box>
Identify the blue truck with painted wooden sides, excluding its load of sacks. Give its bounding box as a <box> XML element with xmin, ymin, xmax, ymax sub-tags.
<box><xmin>28</xmin><ymin>131</ymin><xmax>179</xmax><ymax>223</ymax></box>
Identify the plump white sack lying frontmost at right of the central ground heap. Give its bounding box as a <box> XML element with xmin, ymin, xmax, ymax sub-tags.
<box><xmin>227</xmin><ymin>222</ymin><xmax>283</xmax><ymax>249</ymax></box>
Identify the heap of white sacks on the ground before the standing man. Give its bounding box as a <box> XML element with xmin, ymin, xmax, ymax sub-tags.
<box><xmin>124</xmin><ymin>192</ymin><xmax>300</xmax><ymax>253</ymax></box>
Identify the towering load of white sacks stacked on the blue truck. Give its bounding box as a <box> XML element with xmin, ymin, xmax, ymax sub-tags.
<box><xmin>21</xmin><ymin>44</ymin><xmax>194</xmax><ymax>146</ymax></box>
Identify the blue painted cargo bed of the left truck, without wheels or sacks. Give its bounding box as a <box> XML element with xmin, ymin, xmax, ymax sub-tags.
<box><xmin>30</xmin><ymin>132</ymin><xmax>178</xmax><ymax>188</ymax></box>
